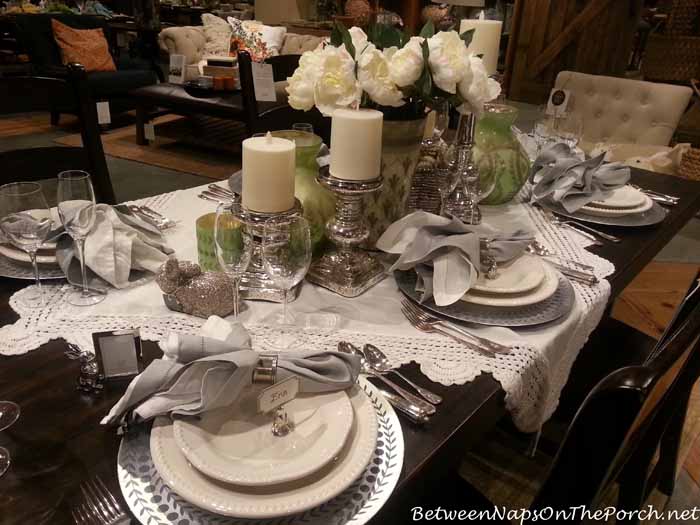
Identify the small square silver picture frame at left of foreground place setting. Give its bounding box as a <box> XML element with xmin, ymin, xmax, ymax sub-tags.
<box><xmin>92</xmin><ymin>328</ymin><xmax>143</xmax><ymax>380</ymax></box>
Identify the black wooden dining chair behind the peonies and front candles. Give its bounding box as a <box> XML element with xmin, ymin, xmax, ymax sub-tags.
<box><xmin>238</xmin><ymin>51</ymin><xmax>330</xmax><ymax>144</ymax></box>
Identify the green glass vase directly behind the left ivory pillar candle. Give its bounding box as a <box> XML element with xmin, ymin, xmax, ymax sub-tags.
<box><xmin>272</xmin><ymin>130</ymin><xmax>335</xmax><ymax>253</ymax></box>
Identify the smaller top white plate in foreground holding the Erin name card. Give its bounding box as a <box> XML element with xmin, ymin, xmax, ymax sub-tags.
<box><xmin>173</xmin><ymin>388</ymin><xmax>353</xmax><ymax>486</ymax></box>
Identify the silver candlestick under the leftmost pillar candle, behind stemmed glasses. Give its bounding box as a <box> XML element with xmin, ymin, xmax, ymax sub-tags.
<box><xmin>236</xmin><ymin>199</ymin><xmax>303</xmax><ymax>303</ymax></box>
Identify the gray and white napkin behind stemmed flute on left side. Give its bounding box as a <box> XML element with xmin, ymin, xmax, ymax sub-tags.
<box><xmin>56</xmin><ymin>204</ymin><xmax>173</xmax><ymax>289</ymax></box>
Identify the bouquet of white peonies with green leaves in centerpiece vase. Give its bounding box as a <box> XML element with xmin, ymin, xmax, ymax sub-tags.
<box><xmin>287</xmin><ymin>22</ymin><xmax>501</xmax><ymax>115</ymax></box>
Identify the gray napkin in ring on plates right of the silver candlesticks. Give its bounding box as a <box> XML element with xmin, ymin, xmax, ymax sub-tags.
<box><xmin>377</xmin><ymin>211</ymin><xmax>534</xmax><ymax>306</ymax></box>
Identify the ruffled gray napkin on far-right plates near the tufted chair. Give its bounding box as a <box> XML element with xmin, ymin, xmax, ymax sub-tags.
<box><xmin>530</xmin><ymin>144</ymin><xmax>630</xmax><ymax>213</ymax></box>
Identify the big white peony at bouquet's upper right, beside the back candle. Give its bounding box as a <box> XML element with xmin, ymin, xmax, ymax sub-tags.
<box><xmin>428</xmin><ymin>31</ymin><xmax>467</xmax><ymax>94</ymax></box>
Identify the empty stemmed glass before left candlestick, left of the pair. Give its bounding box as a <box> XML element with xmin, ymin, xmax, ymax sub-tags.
<box><xmin>214</xmin><ymin>203</ymin><xmax>253</xmax><ymax>319</ymax></box>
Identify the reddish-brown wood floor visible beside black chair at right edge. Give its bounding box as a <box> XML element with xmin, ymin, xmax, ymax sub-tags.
<box><xmin>613</xmin><ymin>262</ymin><xmax>700</xmax><ymax>492</ymax></box>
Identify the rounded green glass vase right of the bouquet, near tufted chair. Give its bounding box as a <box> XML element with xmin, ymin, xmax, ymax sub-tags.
<box><xmin>474</xmin><ymin>104</ymin><xmax>530</xmax><ymax>204</ymax></box>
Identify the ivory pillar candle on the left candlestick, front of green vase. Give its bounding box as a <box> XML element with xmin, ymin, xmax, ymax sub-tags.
<box><xmin>243</xmin><ymin>133</ymin><xmax>296</xmax><ymax>213</ymax></box>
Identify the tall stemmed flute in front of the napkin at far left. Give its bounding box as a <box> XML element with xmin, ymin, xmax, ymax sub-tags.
<box><xmin>57</xmin><ymin>170</ymin><xmax>105</xmax><ymax>306</ymax></box>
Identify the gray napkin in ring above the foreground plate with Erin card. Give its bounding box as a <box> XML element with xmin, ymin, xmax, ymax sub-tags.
<box><xmin>102</xmin><ymin>324</ymin><xmax>360</xmax><ymax>425</ymax></box>
